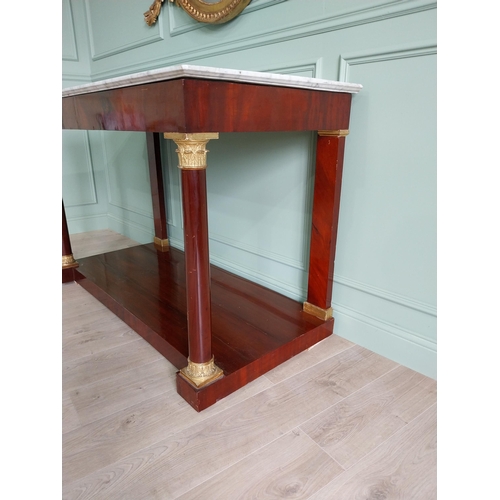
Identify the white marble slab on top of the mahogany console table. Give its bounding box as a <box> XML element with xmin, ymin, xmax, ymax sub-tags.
<box><xmin>62</xmin><ymin>64</ymin><xmax>363</xmax><ymax>97</ymax></box>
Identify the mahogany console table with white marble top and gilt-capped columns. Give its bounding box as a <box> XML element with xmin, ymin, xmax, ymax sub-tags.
<box><xmin>62</xmin><ymin>65</ymin><xmax>361</xmax><ymax>411</ymax></box>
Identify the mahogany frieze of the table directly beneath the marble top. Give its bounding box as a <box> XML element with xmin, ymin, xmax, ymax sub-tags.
<box><xmin>62</xmin><ymin>78</ymin><xmax>352</xmax><ymax>133</ymax></box>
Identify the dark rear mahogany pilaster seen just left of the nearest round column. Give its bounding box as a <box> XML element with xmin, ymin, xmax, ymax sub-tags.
<box><xmin>146</xmin><ymin>132</ymin><xmax>169</xmax><ymax>252</ymax></box>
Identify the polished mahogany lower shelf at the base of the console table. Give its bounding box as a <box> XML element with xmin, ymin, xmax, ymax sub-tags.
<box><xmin>74</xmin><ymin>244</ymin><xmax>333</xmax><ymax>411</ymax></box>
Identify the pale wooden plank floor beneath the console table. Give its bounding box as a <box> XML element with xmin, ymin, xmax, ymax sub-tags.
<box><xmin>62</xmin><ymin>231</ymin><xmax>437</xmax><ymax>500</ymax></box>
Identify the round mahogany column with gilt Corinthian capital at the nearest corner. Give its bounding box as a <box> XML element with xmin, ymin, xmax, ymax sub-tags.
<box><xmin>164</xmin><ymin>133</ymin><xmax>223</xmax><ymax>388</ymax></box>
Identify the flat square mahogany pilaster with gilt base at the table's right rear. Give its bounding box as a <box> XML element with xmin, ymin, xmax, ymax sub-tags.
<box><xmin>304</xmin><ymin>130</ymin><xmax>349</xmax><ymax>320</ymax></box>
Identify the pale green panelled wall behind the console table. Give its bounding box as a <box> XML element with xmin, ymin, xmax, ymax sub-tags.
<box><xmin>63</xmin><ymin>0</ymin><xmax>437</xmax><ymax>377</ymax></box>
